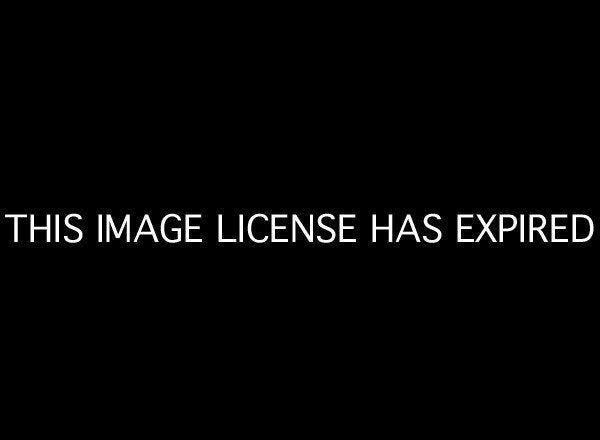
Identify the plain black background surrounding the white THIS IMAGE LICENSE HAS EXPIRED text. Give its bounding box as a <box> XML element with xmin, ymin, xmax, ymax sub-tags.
<box><xmin>1</xmin><ymin>5</ymin><xmax>598</xmax><ymax>433</ymax></box>
